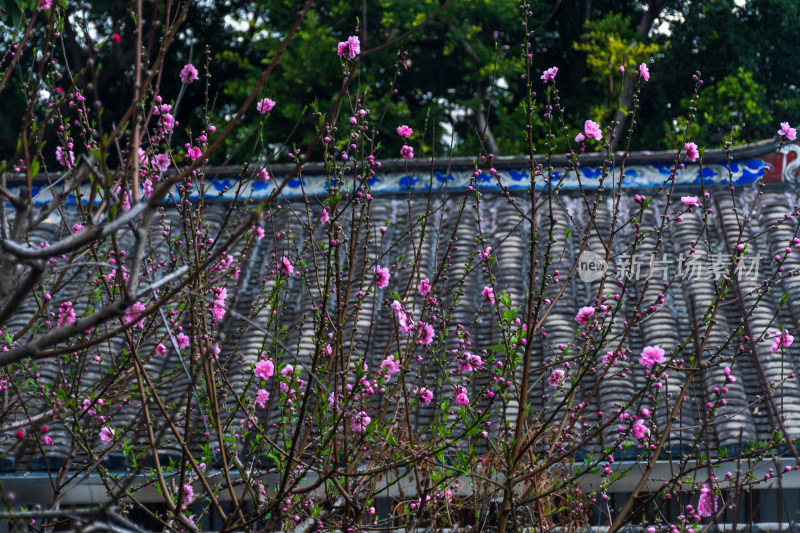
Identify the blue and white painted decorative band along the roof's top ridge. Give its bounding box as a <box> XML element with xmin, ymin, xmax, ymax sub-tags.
<box><xmin>9</xmin><ymin>139</ymin><xmax>800</xmax><ymax>204</ymax></box>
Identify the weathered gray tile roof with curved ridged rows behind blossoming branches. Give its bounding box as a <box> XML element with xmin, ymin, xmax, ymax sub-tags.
<box><xmin>0</xmin><ymin>143</ymin><xmax>800</xmax><ymax>500</ymax></box>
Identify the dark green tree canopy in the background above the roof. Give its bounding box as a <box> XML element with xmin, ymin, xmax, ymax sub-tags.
<box><xmin>0</xmin><ymin>0</ymin><xmax>800</xmax><ymax>163</ymax></box>
